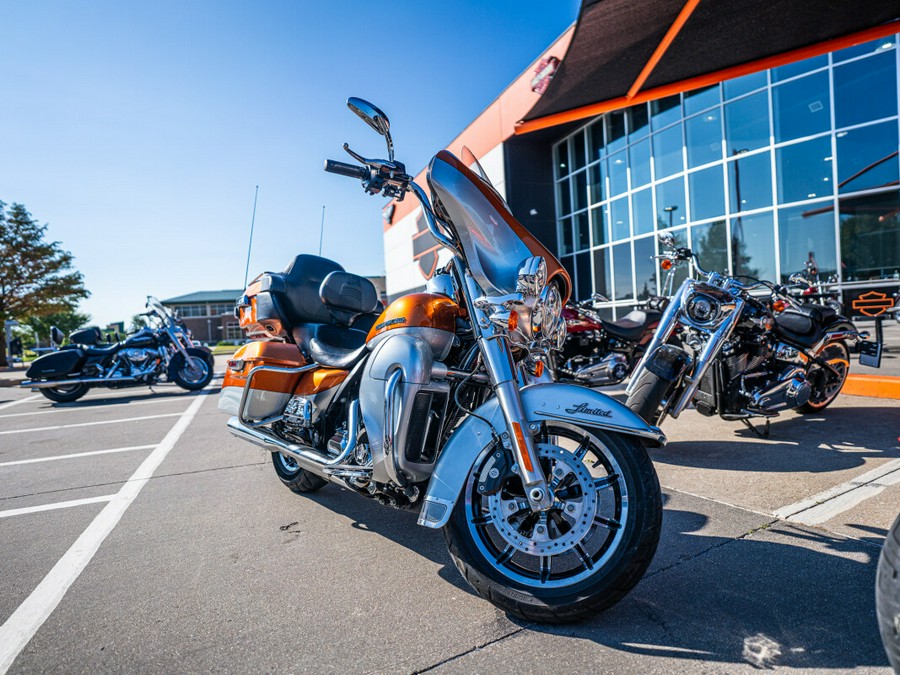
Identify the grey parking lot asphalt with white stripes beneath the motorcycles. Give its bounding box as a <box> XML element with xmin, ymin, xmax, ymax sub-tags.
<box><xmin>0</xmin><ymin>359</ymin><xmax>900</xmax><ymax>673</ymax></box>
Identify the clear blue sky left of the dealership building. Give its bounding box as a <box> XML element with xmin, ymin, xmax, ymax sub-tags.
<box><xmin>0</xmin><ymin>0</ymin><xmax>580</xmax><ymax>324</ymax></box>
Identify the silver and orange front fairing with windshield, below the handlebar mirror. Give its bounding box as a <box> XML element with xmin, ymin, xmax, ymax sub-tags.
<box><xmin>428</xmin><ymin>150</ymin><xmax>571</xmax><ymax>298</ymax></box>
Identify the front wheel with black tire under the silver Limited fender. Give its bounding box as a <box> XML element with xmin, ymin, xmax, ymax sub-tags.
<box><xmin>444</xmin><ymin>422</ymin><xmax>662</xmax><ymax>623</ymax></box>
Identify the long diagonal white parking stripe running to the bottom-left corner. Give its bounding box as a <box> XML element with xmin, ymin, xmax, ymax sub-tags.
<box><xmin>0</xmin><ymin>392</ymin><xmax>209</xmax><ymax>675</ymax></box>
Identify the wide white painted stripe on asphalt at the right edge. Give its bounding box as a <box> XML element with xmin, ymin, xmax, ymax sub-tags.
<box><xmin>775</xmin><ymin>459</ymin><xmax>900</xmax><ymax>525</ymax></box>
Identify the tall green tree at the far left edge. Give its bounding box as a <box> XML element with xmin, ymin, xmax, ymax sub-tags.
<box><xmin>0</xmin><ymin>202</ymin><xmax>90</xmax><ymax>366</ymax></box>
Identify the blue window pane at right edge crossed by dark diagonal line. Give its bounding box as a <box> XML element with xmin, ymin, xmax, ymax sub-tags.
<box><xmin>836</xmin><ymin>122</ymin><xmax>898</xmax><ymax>193</ymax></box>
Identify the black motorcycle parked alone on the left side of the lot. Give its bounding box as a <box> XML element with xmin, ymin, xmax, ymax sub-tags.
<box><xmin>21</xmin><ymin>297</ymin><xmax>213</xmax><ymax>403</ymax></box>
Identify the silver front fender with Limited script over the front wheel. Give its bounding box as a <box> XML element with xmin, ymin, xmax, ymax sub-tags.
<box><xmin>419</xmin><ymin>383</ymin><xmax>666</xmax><ymax>528</ymax></box>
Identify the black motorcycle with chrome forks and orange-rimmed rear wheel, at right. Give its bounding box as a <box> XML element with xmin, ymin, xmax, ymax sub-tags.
<box><xmin>626</xmin><ymin>233</ymin><xmax>880</xmax><ymax>432</ymax></box>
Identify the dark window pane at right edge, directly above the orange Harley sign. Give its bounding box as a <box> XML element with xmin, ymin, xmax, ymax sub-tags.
<box><xmin>840</xmin><ymin>191</ymin><xmax>900</xmax><ymax>281</ymax></box>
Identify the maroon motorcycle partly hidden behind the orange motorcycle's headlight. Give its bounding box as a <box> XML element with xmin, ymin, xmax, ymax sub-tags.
<box><xmin>552</xmin><ymin>294</ymin><xmax>669</xmax><ymax>387</ymax></box>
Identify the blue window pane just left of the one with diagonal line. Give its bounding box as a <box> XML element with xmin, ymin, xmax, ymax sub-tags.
<box><xmin>775</xmin><ymin>136</ymin><xmax>832</xmax><ymax>204</ymax></box>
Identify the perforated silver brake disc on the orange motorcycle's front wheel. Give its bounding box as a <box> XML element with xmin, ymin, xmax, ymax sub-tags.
<box><xmin>488</xmin><ymin>443</ymin><xmax>598</xmax><ymax>556</ymax></box>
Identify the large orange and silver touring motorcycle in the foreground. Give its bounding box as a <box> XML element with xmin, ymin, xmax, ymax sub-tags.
<box><xmin>219</xmin><ymin>98</ymin><xmax>665</xmax><ymax>621</ymax></box>
